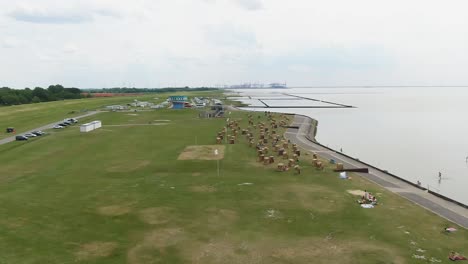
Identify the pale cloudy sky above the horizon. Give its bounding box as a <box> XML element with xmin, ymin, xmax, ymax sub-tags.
<box><xmin>0</xmin><ymin>0</ymin><xmax>468</xmax><ymax>88</ymax></box>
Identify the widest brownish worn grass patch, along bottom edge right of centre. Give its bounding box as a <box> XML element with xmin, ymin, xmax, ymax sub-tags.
<box><xmin>184</xmin><ymin>238</ymin><xmax>404</xmax><ymax>264</ymax></box>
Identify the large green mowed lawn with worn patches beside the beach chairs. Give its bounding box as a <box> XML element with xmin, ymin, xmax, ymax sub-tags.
<box><xmin>0</xmin><ymin>104</ymin><xmax>468</xmax><ymax>264</ymax></box>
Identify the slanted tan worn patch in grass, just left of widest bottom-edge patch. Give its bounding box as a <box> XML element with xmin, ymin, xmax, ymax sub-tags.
<box><xmin>127</xmin><ymin>228</ymin><xmax>186</xmax><ymax>264</ymax></box>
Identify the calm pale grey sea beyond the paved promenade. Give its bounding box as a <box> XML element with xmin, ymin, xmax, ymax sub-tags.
<box><xmin>235</xmin><ymin>87</ymin><xmax>468</xmax><ymax>204</ymax></box>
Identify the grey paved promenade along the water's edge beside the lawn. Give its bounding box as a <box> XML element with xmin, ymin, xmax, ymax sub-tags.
<box><xmin>285</xmin><ymin>115</ymin><xmax>468</xmax><ymax>228</ymax></box>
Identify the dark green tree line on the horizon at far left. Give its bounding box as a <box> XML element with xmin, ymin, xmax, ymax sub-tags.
<box><xmin>0</xmin><ymin>84</ymin><xmax>83</xmax><ymax>106</ymax></box>
